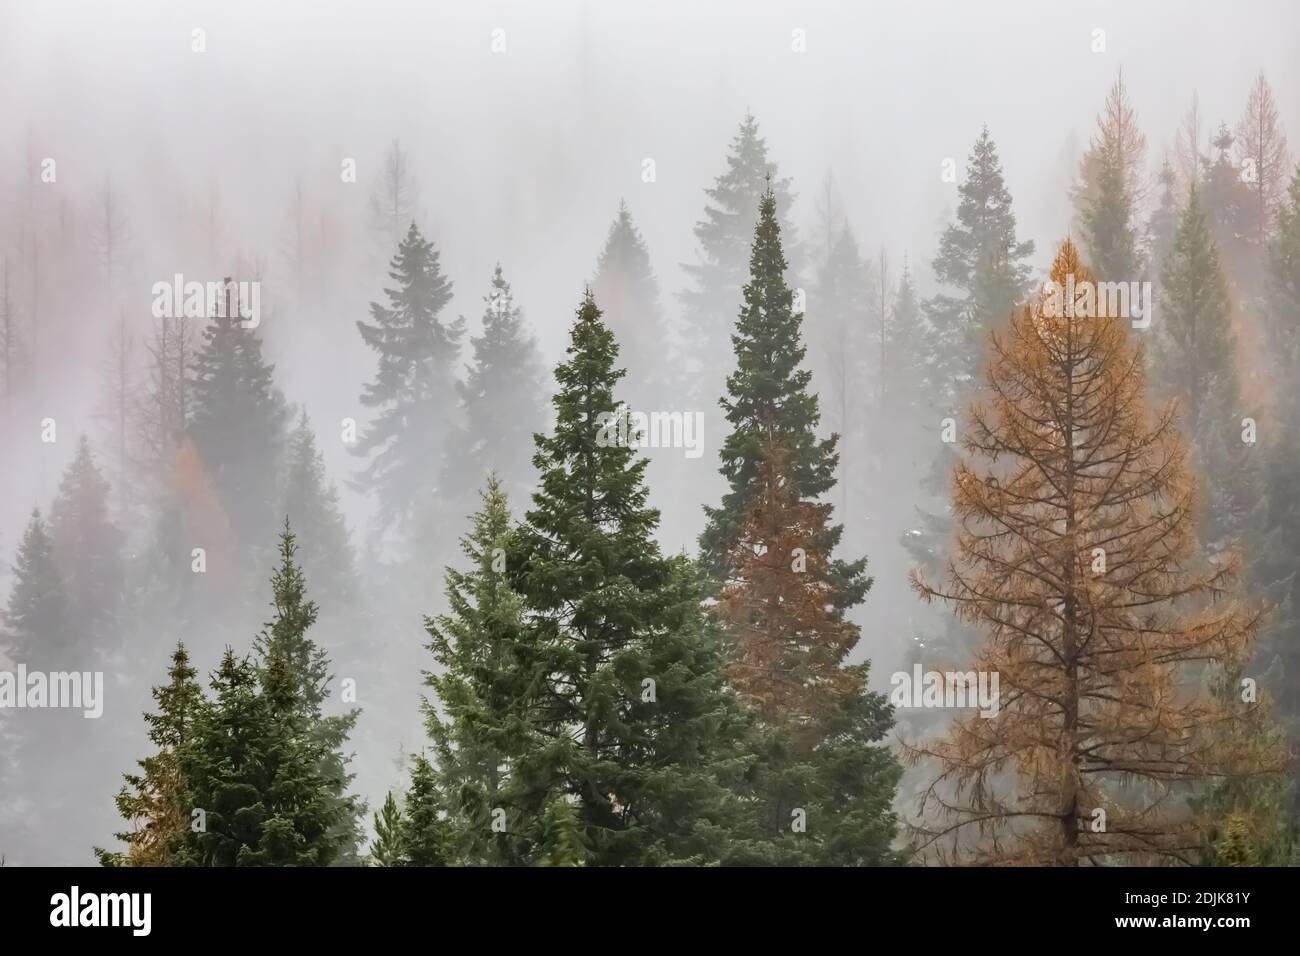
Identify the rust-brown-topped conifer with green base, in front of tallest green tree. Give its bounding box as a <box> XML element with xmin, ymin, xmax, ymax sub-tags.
<box><xmin>718</xmin><ymin>441</ymin><xmax>900</xmax><ymax>865</ymax></box>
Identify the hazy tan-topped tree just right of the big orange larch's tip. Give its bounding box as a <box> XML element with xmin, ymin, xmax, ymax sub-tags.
<box><xmin>1075</xmin><ymin>73</ymin><xmax>1147</xmax><ymax>282</ymax></box>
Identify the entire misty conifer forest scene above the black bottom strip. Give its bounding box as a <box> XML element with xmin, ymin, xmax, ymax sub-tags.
<box><xmin>0</xmin><ymin>0</ymin><xmax>1300</xmax><ymax>866</ymax></box>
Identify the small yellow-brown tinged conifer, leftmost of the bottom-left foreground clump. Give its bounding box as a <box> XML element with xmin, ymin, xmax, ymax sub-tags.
<box><xmin>95</xmin><ymin>643</ymin><xmax>203</xmax><ymax>866</ymax></box>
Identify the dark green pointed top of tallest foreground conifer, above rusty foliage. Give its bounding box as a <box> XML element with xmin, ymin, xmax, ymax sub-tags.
<box><xmin>699</xmin><ymin>189</ymin><xmax>839</xmax><ymax>580</ymax></box>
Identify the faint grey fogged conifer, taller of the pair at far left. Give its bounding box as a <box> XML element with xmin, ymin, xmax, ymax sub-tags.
<box><xmin>49</xmin><ymin>436</ymin><xmax>126</xmax><ymax>658</ymax></box>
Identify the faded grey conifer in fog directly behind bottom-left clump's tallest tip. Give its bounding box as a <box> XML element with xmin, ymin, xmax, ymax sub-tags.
<box><xmin>281</xmin><ymin>408</ymin><xmax>356</xmax><ymax>601</ymax></box>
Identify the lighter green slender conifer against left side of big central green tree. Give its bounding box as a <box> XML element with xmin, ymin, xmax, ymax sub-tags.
<box><xmin>424</xmin><ymin>476</ymin><xmax>533</xmax><ymax>864</ymax></box>
